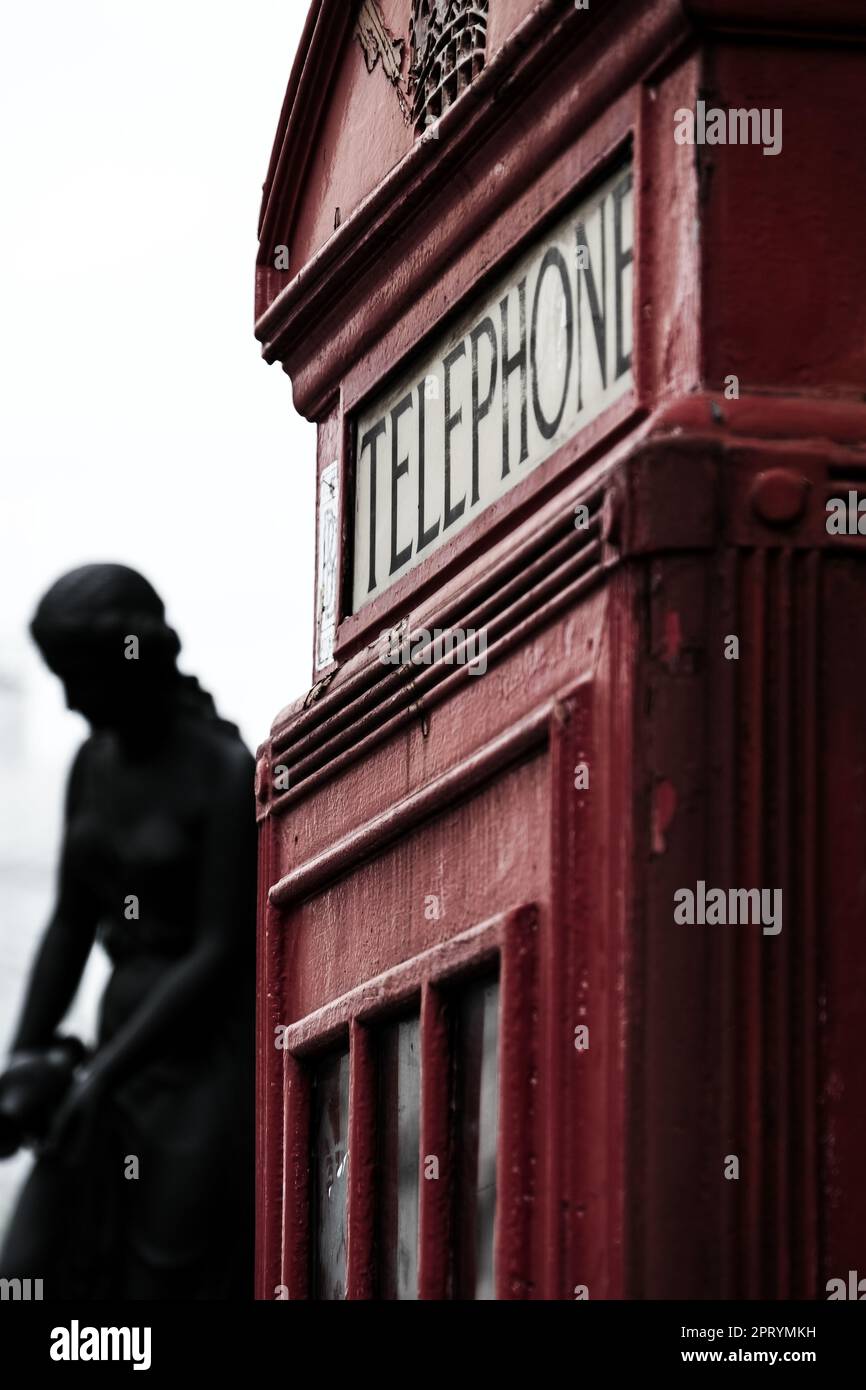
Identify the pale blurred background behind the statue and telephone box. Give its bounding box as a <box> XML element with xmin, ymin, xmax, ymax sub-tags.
<box><xmin>0</xmin><ymin>0</ymin><xmax>316</xmax><ymax>1230</ymax></box>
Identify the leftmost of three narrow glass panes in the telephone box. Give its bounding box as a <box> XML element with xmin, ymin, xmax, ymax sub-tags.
<box><xmin>311</xmin><ymin>1052</ymin><xmax>349</xmax><ymax>1300</ymax></box>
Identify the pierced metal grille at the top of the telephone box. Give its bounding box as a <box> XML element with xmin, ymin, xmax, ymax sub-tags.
<box><xmin>409</xmin><ymin>0</ymin><xmax>488</xmax><ymax>133</ymax></box>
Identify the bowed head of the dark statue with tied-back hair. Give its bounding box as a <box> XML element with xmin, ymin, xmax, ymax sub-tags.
<box><xmin>31</xmin><ymin>564</ymin><xmax>181</xmax><ymax>730</ymax></box>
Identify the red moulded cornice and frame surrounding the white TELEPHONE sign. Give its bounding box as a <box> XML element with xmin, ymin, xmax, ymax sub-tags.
<box><xmin>256</xmin><ymin>0</ymin><xmax>696</xmax><ymax>677</ymax></box>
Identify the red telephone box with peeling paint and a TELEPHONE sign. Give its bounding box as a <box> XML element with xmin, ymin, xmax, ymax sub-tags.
<box><xmin>256</xmin><ymin>0</ymin><xmax>866</xmax><ymax>1298</ymax></box>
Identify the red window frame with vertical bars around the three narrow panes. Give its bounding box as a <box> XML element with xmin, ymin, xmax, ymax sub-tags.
<box><xmin>281</xmin><ymin>905</ymin><xmax>538</xmax><ymax>1298</ymax></box>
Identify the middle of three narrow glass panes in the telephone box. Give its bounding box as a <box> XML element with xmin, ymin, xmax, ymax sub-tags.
<box><xmin>378</xmin><ymin>1019</ymin><xmax>421</xmax><ymax>1300</ymax></box>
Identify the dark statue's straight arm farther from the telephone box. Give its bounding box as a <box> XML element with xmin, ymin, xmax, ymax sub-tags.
<box><xmin>13</xmin><ymin>744</ymin><xmax>97</xmax><ymax>1052</ymax></box>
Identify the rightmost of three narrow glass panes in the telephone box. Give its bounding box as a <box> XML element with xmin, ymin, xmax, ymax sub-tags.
<box><xmin>455</xmin><ymin>980</ymin><xmax>499</xmax><ymax>1300</ymax></box>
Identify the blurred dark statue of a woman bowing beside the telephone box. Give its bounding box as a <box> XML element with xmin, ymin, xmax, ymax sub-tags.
<box><xmin>0</xmin><ymin>564</ymin><xmax>256</xmax><ymax>1300</ymax></box>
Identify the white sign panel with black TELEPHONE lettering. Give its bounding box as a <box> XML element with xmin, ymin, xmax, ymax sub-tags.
<box><xmin>353</xmin><ymin>167</ymin><xmax>634</xmax><ymax>612</ymax></box>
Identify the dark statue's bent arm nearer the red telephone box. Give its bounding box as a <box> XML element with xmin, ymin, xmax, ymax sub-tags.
<box><xmin>90</xmin><ymin>745</ymin><xmax>256</xmax><ymax>1086</ymax></box>
